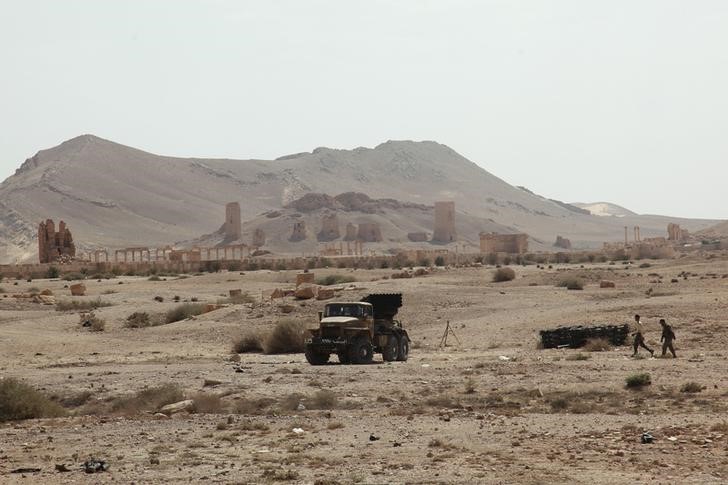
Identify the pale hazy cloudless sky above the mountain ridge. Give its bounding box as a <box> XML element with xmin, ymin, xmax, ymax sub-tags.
<box><xmin>0</xmin><ymin>0</ymin><xmax>728</xmax><ymax>218</ymax></box>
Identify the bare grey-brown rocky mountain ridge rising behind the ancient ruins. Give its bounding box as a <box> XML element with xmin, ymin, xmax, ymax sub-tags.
<box><xmin>0</xmin><ymin>135</ymin><xmax>718</xmax><ymax>262</ymax></box>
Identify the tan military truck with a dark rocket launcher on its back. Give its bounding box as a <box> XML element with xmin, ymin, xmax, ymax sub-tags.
<box><xmin>305</xmin><ymin>293</ymin><xmax>410</xmax><ymax>365</ymax></box>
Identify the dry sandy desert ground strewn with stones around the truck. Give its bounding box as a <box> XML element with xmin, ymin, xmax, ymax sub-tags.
<box><xmin>0</xmin><ymin>254</ymin><xmax>728</xmax><ymax>485</ymax></box>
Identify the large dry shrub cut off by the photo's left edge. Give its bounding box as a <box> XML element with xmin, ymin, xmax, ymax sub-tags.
<box><xmin>0</xmin><ymin>377</ymin><xmax>65</xmax><ymax>422</ymax></box>
